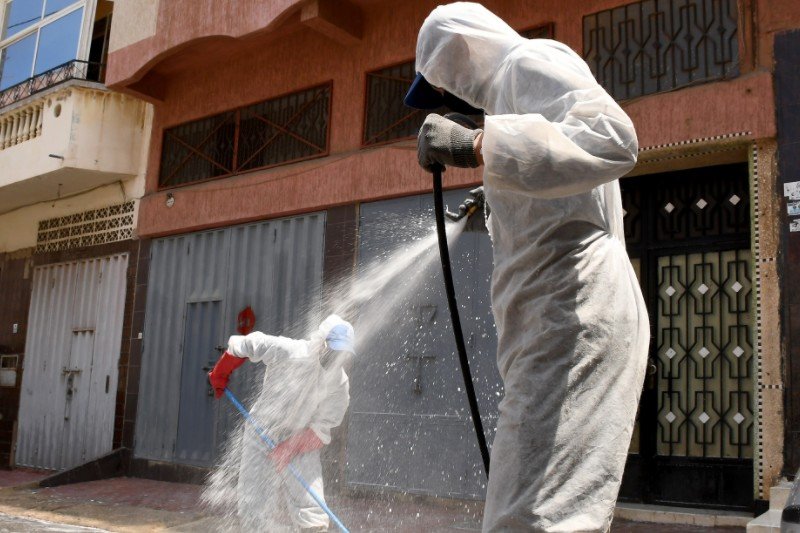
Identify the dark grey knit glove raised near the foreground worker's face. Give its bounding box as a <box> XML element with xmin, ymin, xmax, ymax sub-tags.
<box><xmin>417</xmin><ymin>113</ymin><xmax>482</xmax><ymax>172</ymax></box>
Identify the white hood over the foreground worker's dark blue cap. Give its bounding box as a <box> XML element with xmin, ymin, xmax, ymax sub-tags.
<box><xmin>416</xmin><ymin>2</ymin><xmax>527</xmax><ymax>111</ymax></box>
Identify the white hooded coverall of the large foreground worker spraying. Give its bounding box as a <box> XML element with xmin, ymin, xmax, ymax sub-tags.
<box><xmin>417</xmin><ymin>3</ymin><xmax>650</xmax><ymax>531</ymax></box>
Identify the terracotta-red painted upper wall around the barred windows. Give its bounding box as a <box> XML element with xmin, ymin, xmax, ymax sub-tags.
<box><xmin>108</xmin><ymin>0</ymin><xmax>780</xmax><ymax>236</ymax></box>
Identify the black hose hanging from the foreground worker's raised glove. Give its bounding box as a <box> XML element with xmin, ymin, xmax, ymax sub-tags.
<box><xmin>433</xmin><ymin>166</ymin><xmax>489</xmax><ymax>478</ymax></box>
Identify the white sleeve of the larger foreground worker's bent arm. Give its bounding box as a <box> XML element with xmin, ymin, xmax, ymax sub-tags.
<box><xmin>482</xmin><ymin>41</ymin><xmax>638</xmax><ymax>198</ymax></box>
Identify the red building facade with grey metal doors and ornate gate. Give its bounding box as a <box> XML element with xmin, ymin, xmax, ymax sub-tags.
<box><xmin>98</xmin><ymin>0</ymin><xmax>800</xmax><ymax>511</ymax></box>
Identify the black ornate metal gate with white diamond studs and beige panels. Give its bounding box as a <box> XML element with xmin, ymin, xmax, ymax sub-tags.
<box><xmin>621</xmin><ymin>164</ymin><xmax>755</xmax><ymax>509</ymax></box>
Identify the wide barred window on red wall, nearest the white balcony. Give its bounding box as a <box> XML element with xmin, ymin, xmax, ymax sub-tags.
<box><xmin>159</xmin><ymin>83</ymin><xmax>331</xmax><ymax>188</ymax></box>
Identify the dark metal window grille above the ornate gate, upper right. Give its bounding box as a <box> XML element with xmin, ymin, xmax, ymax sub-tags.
<box><xmin>583</xmin><ymin>0</ymin><xmax>739</xmax><ymax>100</ymax></box>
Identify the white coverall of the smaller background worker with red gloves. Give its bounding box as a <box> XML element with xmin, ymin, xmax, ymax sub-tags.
<box><xmin>228</xmin><ymin>315</ymin><xmax>350</xmax><ymax>532</ymax></box>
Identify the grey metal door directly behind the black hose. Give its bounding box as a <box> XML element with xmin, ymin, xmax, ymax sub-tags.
<box><xmin>347</xmin><ymin>191</ymin><xmax>501</xmax><ymax>497</ymax></box>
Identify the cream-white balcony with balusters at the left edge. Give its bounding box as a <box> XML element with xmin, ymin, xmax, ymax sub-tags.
<box><xmin>0</xmin><ymin>80</ymin><xmax>145</xmax><ymax>214</ymax></box>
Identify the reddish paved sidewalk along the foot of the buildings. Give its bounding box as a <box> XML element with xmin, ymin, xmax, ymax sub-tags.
<box><xmin>0</xmin><ymin>470</ymin><xmax>743</xmax><ymax>533</ymax></box>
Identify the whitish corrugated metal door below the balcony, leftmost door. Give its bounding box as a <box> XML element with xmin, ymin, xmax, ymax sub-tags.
<box><xmin>16</xmin><ymin>254</ymin><xmax>128</xmax><ymax>470</ymax></box>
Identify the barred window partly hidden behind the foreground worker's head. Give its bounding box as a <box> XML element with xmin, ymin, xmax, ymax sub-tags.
<box><xmin>362</xmin><ymin>24</ymin><xmax>553</xmax><ymax>146</ymax></box>
